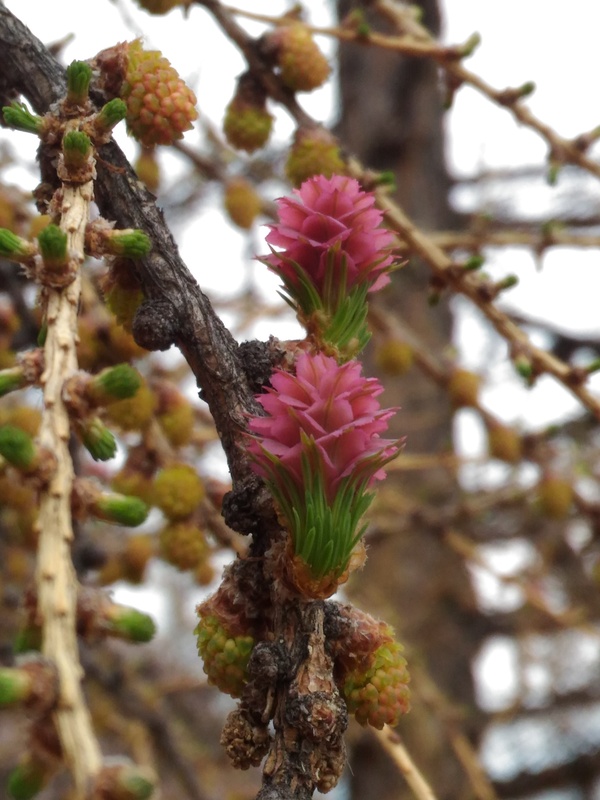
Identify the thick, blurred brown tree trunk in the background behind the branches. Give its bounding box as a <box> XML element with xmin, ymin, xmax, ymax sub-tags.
<box><xmin>338</xmin><ymin>0</ymin><xmax>479</xmax><ymax>800</ymax></box>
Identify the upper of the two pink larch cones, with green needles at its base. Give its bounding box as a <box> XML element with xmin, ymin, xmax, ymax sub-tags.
<box><xmin>259</xmin><ymin>175</ymin><xmax>394</xmax><ymax>359</ymax></box>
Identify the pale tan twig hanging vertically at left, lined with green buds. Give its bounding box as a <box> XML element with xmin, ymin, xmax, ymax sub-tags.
<box><xmin>36</xmin><ymin>170</ymin><xmax>101</xmax><ymax>799</ymax></box>
